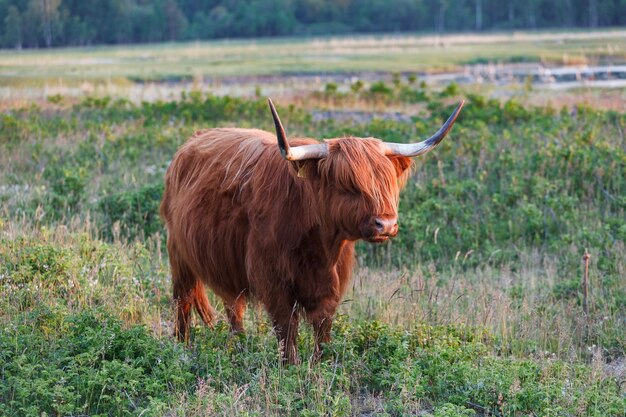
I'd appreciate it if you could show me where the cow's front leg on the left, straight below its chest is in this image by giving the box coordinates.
[267,302,300,364]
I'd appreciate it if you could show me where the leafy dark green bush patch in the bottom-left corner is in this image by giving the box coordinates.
[0,308,194,416]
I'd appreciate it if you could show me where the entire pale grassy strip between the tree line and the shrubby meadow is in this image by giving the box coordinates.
[0,29,626,111]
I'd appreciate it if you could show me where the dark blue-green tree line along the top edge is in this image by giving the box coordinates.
[0,0,626,49]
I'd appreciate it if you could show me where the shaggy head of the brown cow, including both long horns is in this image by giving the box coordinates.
[268,99,464,242]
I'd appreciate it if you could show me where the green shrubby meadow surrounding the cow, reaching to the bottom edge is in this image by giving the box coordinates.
[0,34,626,417]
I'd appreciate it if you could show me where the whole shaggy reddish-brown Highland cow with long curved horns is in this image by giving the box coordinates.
[161,100,463,363]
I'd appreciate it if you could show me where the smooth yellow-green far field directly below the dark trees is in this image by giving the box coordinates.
[0,29,626,86]
